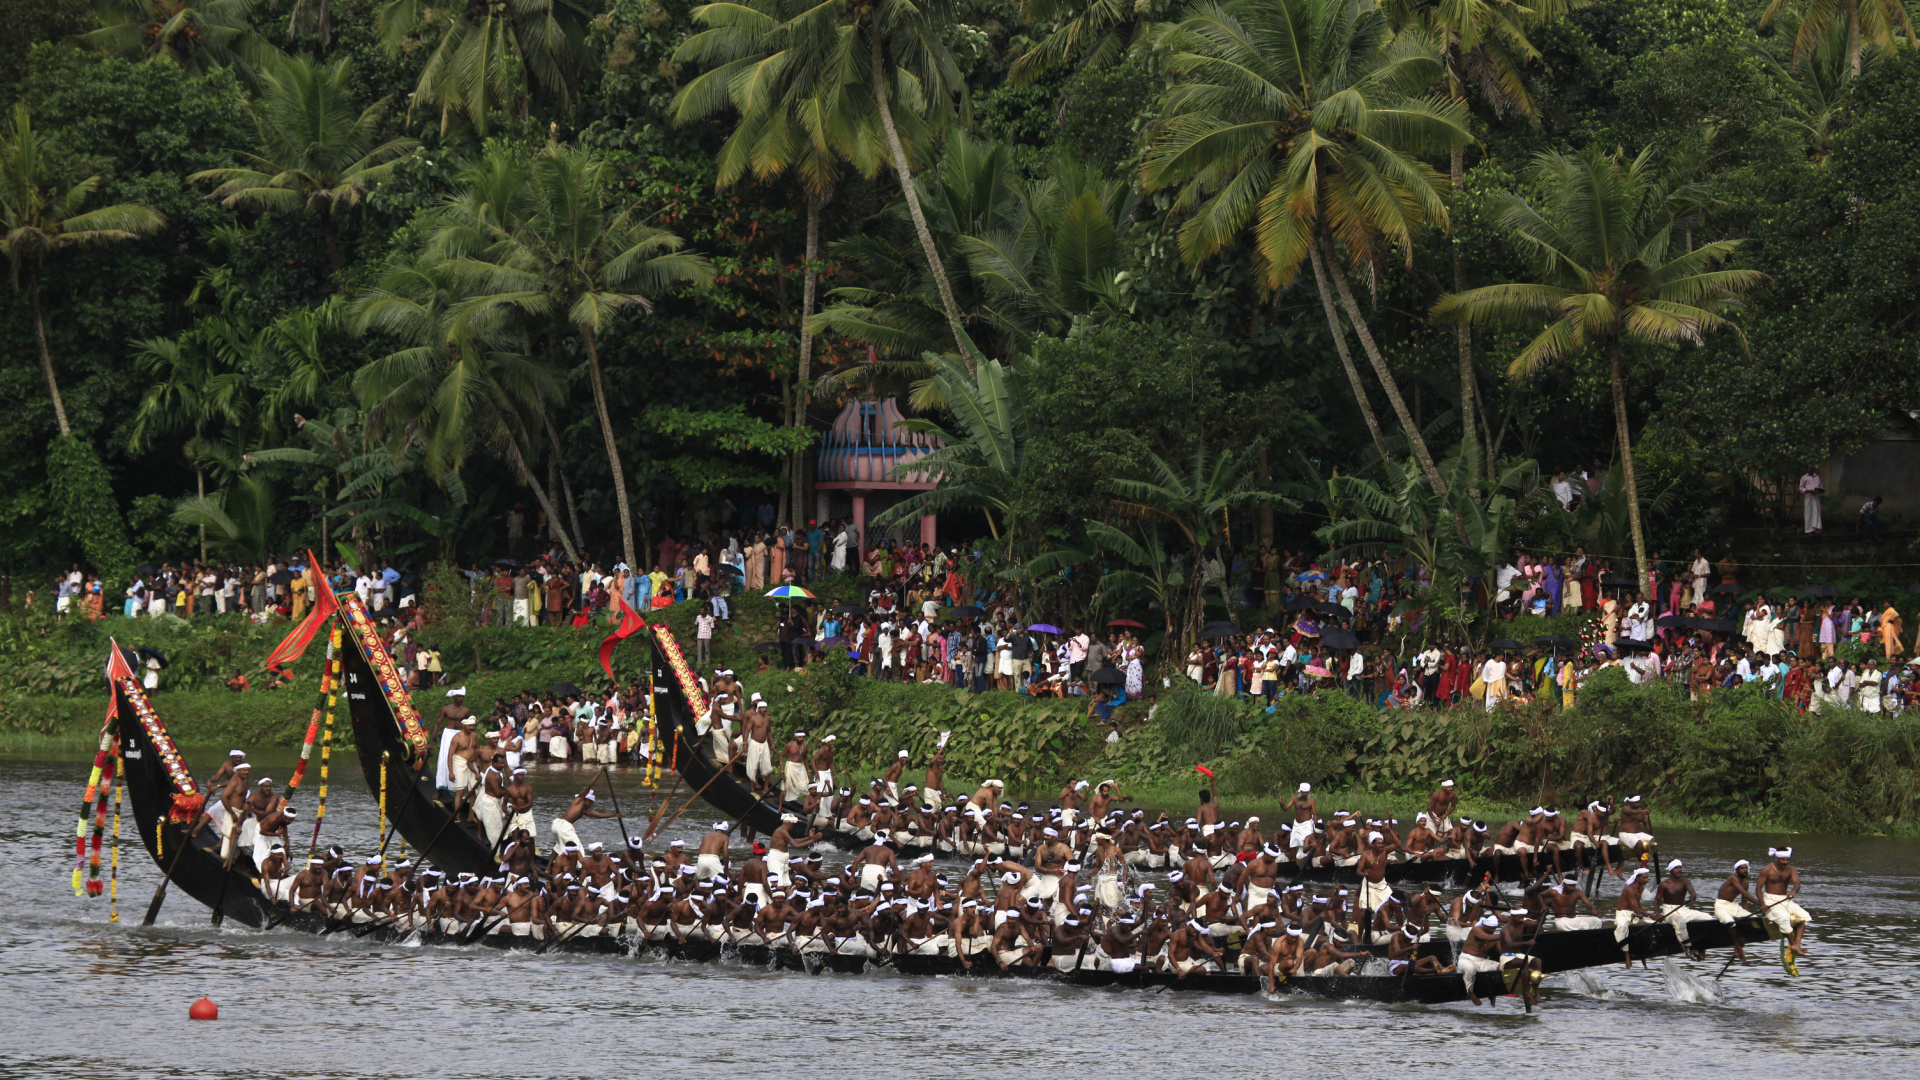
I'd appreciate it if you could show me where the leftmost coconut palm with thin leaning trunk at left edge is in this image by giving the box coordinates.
[0,104,167,436]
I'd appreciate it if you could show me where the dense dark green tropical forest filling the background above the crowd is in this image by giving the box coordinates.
[0,0,1920,584]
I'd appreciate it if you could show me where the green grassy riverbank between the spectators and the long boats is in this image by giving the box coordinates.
[0,582,1920,836]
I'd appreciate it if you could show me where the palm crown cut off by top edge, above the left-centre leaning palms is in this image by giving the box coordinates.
[374,0,588,135]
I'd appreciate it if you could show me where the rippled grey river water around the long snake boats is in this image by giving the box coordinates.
[0,749,1920,1080]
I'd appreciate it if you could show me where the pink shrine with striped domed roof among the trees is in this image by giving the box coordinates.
[814,398,943,555]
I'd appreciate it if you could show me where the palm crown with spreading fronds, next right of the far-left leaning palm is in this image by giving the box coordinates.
[186,56,419,273]
